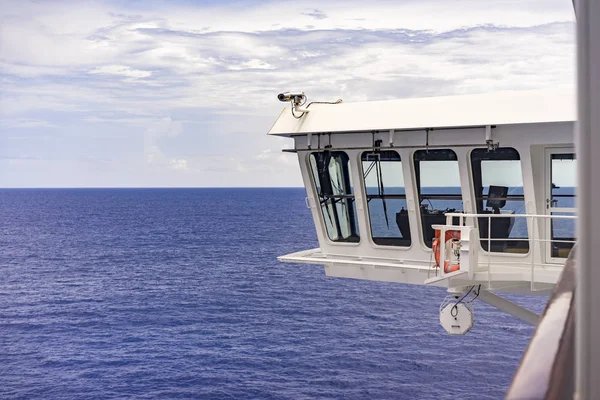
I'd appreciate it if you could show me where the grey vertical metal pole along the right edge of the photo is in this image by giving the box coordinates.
[576,0,600,400]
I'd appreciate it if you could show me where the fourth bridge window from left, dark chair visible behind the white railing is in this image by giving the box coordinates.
[471,147,529,253]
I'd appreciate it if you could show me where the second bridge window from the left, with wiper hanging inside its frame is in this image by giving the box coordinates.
[361,151,410,246]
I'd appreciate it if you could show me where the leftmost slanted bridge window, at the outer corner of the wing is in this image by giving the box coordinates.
[309,151,360,242]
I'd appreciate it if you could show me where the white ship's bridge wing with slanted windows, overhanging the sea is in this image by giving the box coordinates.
[269,88,577,334]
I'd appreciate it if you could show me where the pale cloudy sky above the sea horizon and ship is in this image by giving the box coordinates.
[0,0,576,187]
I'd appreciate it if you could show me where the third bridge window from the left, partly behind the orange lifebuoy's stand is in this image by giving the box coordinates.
[414,149,463,247]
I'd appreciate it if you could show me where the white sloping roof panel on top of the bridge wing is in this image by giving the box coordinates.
[269,89,577,136]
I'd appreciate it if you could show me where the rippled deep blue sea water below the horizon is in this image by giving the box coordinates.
[0,189,545,399]
